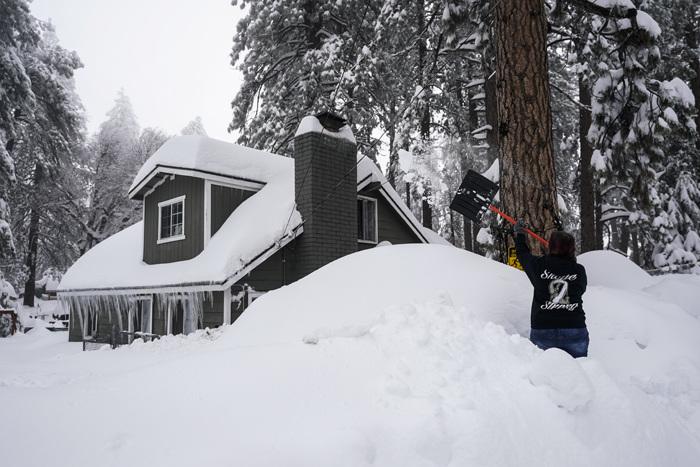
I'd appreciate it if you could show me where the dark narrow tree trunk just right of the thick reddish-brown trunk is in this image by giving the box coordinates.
[578,76,596,252]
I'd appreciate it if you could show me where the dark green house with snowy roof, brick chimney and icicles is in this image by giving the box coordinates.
[58,113,440,340]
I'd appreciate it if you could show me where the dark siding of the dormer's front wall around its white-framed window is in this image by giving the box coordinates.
[143,175,204,264]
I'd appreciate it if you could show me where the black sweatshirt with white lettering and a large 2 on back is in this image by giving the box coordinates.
[515,234,587,329]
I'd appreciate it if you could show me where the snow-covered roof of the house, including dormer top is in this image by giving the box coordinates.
[63,136,444,295]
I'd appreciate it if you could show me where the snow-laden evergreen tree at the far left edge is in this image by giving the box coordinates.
[0,1,83,306]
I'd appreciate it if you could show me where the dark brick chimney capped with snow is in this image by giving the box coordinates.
[294,112,357,278]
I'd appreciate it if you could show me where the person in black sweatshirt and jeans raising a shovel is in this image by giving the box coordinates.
[513,221,589,358]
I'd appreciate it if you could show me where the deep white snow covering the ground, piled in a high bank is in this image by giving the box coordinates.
[0,246,700,467]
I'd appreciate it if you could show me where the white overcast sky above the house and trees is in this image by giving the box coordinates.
[31,0,242,141]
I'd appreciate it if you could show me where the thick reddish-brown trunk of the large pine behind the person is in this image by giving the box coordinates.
[495,0,558,256]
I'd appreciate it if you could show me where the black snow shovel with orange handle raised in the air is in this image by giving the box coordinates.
[450,170,549,247]
